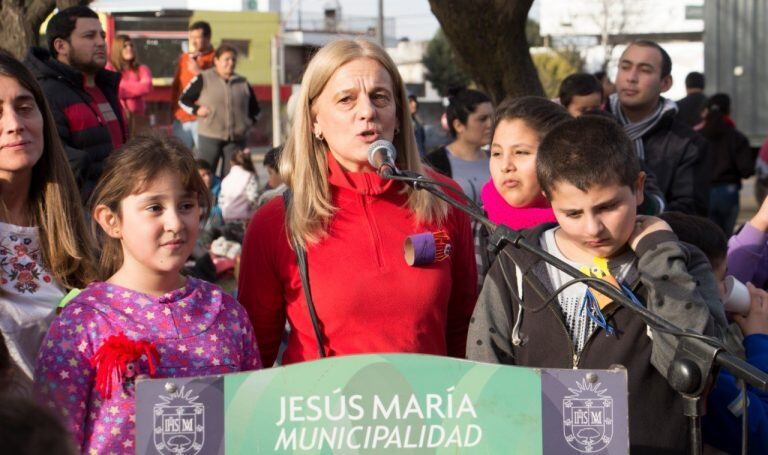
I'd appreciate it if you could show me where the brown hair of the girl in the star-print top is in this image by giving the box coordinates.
[90,133,211,280]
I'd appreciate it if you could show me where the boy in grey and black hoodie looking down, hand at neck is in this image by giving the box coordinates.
[467,116,719,454]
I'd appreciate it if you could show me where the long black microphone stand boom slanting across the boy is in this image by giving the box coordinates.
[388,169,768,455]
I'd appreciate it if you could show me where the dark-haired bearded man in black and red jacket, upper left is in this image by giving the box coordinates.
[24,6,127,203]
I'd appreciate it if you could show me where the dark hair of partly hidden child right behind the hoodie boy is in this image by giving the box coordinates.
[659,212,728,266]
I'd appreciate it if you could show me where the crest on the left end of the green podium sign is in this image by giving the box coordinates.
[153,387,205,455]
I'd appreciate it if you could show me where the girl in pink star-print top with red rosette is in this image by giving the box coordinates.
[35,136,261,454]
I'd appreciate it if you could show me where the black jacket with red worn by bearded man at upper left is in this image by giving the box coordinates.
[24,47,127,203]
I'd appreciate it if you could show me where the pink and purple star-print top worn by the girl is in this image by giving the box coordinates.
[35,278,261,454]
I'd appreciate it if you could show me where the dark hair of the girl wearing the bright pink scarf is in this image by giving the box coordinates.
[493,96,571,141]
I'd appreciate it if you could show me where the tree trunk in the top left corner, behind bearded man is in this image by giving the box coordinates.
[0,0,90,59]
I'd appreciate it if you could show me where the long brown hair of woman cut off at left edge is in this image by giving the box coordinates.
[0,50,96,289]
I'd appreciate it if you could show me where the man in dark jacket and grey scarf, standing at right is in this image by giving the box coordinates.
[608,40,710,216]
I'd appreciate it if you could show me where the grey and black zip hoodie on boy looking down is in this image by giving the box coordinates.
[467,224,719,455]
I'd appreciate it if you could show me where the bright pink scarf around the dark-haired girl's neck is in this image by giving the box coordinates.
[480,180,557,230]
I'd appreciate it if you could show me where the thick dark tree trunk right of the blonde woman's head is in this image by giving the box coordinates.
[429,0,544,104]
